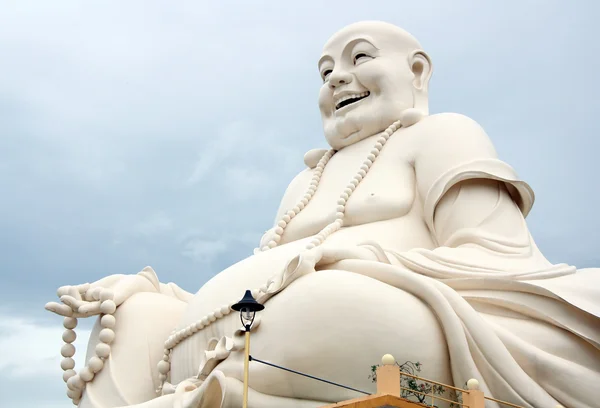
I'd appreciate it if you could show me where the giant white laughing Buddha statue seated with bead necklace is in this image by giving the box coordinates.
[46,22,600,408]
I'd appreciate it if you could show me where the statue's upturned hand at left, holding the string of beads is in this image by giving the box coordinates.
[46,268,158,317]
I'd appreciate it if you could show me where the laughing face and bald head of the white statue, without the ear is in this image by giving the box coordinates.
[319,22,420,150]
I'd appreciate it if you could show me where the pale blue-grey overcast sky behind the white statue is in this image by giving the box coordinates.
[0,0,600,408]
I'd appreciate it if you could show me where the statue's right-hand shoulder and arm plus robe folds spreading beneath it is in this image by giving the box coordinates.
[394,114,572,279]
